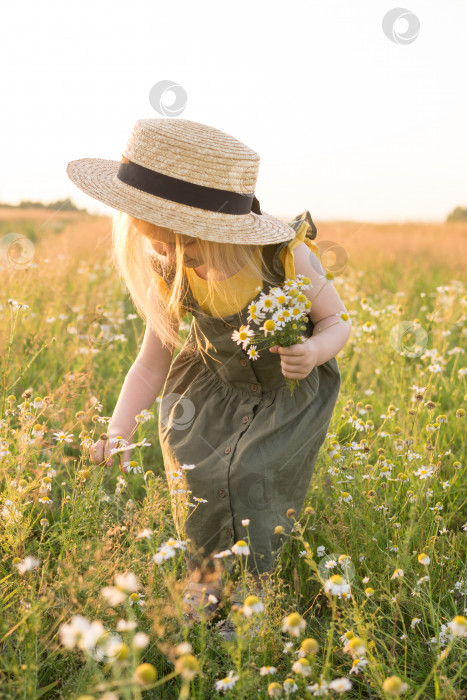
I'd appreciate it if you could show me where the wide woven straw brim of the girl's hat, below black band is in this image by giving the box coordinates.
[66,158,295,245]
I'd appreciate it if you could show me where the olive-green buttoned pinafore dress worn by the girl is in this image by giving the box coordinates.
[158,213,341,574]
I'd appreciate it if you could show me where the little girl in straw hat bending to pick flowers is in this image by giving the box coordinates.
[67,118,350,636]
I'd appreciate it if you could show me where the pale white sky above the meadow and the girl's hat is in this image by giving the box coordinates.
[0,0,467,222]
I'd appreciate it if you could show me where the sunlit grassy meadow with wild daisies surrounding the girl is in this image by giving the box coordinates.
[0,209,467,700]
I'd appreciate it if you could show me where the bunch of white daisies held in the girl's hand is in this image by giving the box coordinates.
[232,275,313,394]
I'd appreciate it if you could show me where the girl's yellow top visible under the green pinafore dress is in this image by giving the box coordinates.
[155,221,318,318]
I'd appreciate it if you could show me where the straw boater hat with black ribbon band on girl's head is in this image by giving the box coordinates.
[67,117,295,245]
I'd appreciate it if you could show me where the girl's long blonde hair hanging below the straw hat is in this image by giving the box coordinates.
[112,210,277,348]
